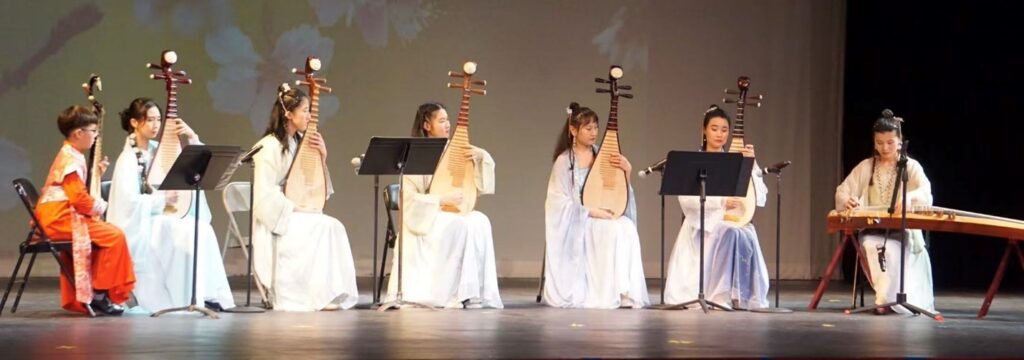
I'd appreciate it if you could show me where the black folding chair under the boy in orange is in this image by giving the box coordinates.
[0,178,96,317]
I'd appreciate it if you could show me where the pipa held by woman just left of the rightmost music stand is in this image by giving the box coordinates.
[585,65,633,218]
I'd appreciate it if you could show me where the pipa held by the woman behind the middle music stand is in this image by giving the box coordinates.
[428,61,487,215]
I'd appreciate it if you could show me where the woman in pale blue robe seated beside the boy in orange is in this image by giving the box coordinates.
[106,97,234,312]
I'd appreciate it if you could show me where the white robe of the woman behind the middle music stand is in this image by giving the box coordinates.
[385,147,505,309]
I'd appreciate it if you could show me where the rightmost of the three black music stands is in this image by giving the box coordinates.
[655,151,754,314]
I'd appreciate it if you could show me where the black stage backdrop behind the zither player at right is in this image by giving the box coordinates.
[842,1,1024,289]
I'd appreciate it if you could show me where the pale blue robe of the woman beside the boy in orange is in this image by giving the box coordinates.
[106,141,234,312]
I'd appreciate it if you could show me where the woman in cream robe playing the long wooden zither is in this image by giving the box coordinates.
[836,114,935,315]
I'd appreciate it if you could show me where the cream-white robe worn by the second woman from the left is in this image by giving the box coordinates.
[253,135,359,311]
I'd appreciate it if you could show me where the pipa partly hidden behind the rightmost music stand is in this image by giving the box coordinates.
[723,77,762,227]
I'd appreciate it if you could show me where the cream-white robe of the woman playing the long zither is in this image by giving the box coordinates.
[836,159,935,314]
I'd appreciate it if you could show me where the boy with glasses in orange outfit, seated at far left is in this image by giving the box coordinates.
[36,105,135,315]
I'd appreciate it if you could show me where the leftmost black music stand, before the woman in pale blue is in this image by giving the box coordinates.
[152,145,242,319]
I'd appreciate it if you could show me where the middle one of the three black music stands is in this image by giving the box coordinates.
[359,136,447,311]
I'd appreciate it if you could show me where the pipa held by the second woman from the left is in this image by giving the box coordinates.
[285,56,331,213]
